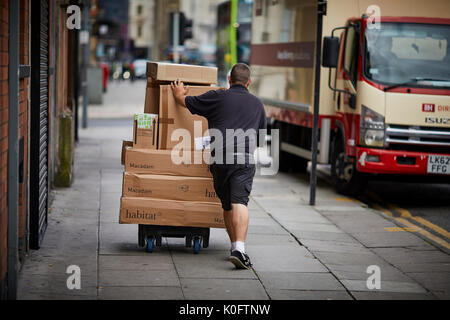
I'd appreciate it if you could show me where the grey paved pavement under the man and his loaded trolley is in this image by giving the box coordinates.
[19,83,450,300]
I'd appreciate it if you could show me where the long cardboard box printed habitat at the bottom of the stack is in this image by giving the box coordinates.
[119,197,225,228]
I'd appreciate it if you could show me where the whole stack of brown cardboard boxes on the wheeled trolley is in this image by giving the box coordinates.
[119,62,225,228]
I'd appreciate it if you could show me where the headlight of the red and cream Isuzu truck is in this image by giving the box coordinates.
[360,105,385,147]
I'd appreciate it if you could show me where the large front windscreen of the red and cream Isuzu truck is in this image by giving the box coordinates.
[364,22,450,88]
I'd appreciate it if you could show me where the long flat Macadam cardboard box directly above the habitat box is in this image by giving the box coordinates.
[122,172,220,203]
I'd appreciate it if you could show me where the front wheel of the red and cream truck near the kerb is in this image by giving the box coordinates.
[331,134,367,196]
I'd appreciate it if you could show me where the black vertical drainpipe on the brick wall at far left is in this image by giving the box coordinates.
[7,0,20,300]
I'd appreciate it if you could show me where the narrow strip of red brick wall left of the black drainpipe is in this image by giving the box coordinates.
[0,0,9,295]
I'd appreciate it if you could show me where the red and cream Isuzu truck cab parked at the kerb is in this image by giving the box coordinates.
[324,15,450,194]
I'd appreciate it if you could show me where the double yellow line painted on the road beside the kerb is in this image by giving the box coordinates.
[369,192,450,250]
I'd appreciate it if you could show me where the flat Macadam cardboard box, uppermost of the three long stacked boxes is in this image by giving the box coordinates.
[125,147,212,178]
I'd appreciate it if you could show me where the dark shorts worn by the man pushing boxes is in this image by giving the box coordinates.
[210,164,256,211]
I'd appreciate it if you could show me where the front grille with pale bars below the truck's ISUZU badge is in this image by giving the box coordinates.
[386,125,450,147]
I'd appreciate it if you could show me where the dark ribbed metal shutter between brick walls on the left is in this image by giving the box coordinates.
[30,0,49,249]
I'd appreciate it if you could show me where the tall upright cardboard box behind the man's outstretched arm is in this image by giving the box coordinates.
[157,86,219,150]
